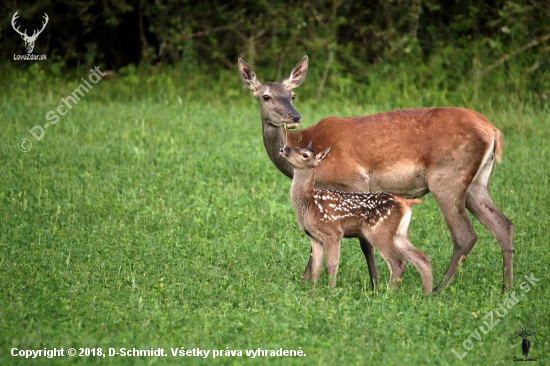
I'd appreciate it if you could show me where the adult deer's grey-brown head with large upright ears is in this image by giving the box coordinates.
[239,56,309,129]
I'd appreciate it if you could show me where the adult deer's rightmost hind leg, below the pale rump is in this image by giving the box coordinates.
[466,156,514,291]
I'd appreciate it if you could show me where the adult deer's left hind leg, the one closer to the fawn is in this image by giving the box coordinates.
[430,172,477,292]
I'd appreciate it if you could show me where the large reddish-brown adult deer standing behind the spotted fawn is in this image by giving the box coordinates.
[238,56,514,291]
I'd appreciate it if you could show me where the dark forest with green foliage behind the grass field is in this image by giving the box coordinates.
[0,0,550,95]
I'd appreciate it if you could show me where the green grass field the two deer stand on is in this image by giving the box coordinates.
[0,67,550,365]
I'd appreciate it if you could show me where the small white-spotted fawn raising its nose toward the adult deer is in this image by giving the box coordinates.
[280,143,433,293]
